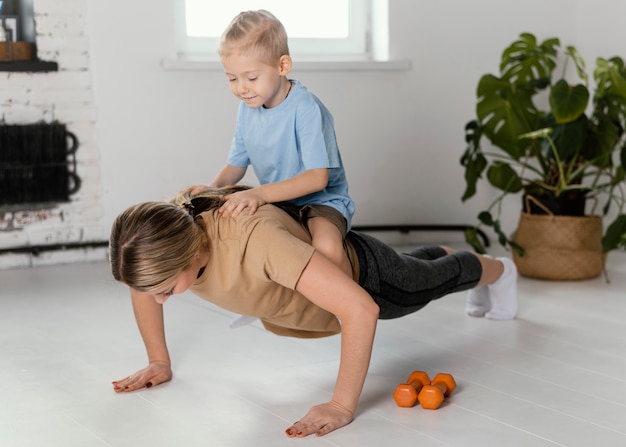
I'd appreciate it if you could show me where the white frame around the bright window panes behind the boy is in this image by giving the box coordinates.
[174,0,375,61]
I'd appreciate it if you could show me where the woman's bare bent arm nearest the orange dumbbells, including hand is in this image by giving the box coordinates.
[286,253,379,437]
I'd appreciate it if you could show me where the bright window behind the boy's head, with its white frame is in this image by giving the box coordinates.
[176,0,376,60]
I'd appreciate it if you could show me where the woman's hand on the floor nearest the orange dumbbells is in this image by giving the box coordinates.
[285,400,352,438]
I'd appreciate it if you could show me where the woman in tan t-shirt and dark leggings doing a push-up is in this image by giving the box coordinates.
[110,187,517,437]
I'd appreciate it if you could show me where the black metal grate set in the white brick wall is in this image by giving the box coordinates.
[0,123,80,205]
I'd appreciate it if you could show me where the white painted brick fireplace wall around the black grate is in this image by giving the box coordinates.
[0,0,106,268]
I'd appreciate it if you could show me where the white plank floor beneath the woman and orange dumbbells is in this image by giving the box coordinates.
[0,245,626,447]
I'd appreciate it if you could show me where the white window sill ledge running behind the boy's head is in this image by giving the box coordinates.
[161,59,413,72]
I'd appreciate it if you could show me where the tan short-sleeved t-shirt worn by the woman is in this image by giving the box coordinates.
[190,205,341,338]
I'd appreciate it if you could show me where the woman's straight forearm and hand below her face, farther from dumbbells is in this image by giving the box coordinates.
[113,289,172,392]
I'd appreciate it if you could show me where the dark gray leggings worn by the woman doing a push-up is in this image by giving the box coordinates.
[346,231,482,320]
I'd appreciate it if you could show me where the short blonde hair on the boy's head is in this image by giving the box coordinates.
[218,9,289,65]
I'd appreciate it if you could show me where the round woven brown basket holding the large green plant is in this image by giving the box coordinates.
[513,212,605,280]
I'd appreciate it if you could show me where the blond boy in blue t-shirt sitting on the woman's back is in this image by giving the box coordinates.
[204,10,354,275]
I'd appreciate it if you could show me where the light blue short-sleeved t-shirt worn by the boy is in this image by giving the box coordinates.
[228,80,354,228]
